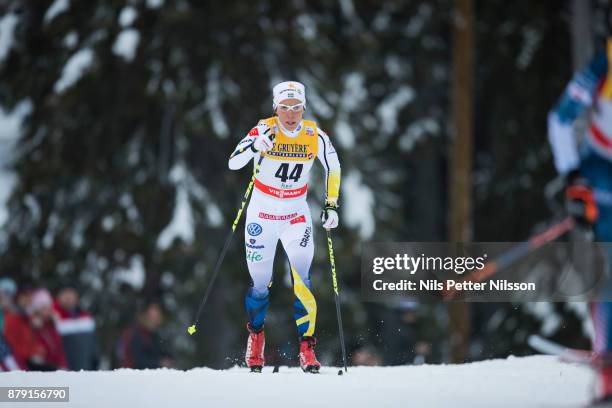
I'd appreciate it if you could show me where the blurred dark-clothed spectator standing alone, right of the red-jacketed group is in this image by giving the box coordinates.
[118,302,174,369]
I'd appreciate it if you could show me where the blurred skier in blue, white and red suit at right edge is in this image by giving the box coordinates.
[548,39,612,400]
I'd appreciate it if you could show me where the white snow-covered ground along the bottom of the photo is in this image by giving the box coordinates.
[0,356,593,408]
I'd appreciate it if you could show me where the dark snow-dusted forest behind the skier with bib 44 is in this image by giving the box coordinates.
[0,0,604,368]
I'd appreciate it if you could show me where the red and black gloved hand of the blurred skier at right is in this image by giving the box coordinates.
[565,171,599,225]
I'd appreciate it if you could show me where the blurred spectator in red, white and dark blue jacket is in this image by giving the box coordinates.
[53,286,99,371]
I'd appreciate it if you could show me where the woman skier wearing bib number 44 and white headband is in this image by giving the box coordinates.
[228,81,340,373]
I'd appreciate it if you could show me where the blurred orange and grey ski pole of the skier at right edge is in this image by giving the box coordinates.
[442,217,576,299]
